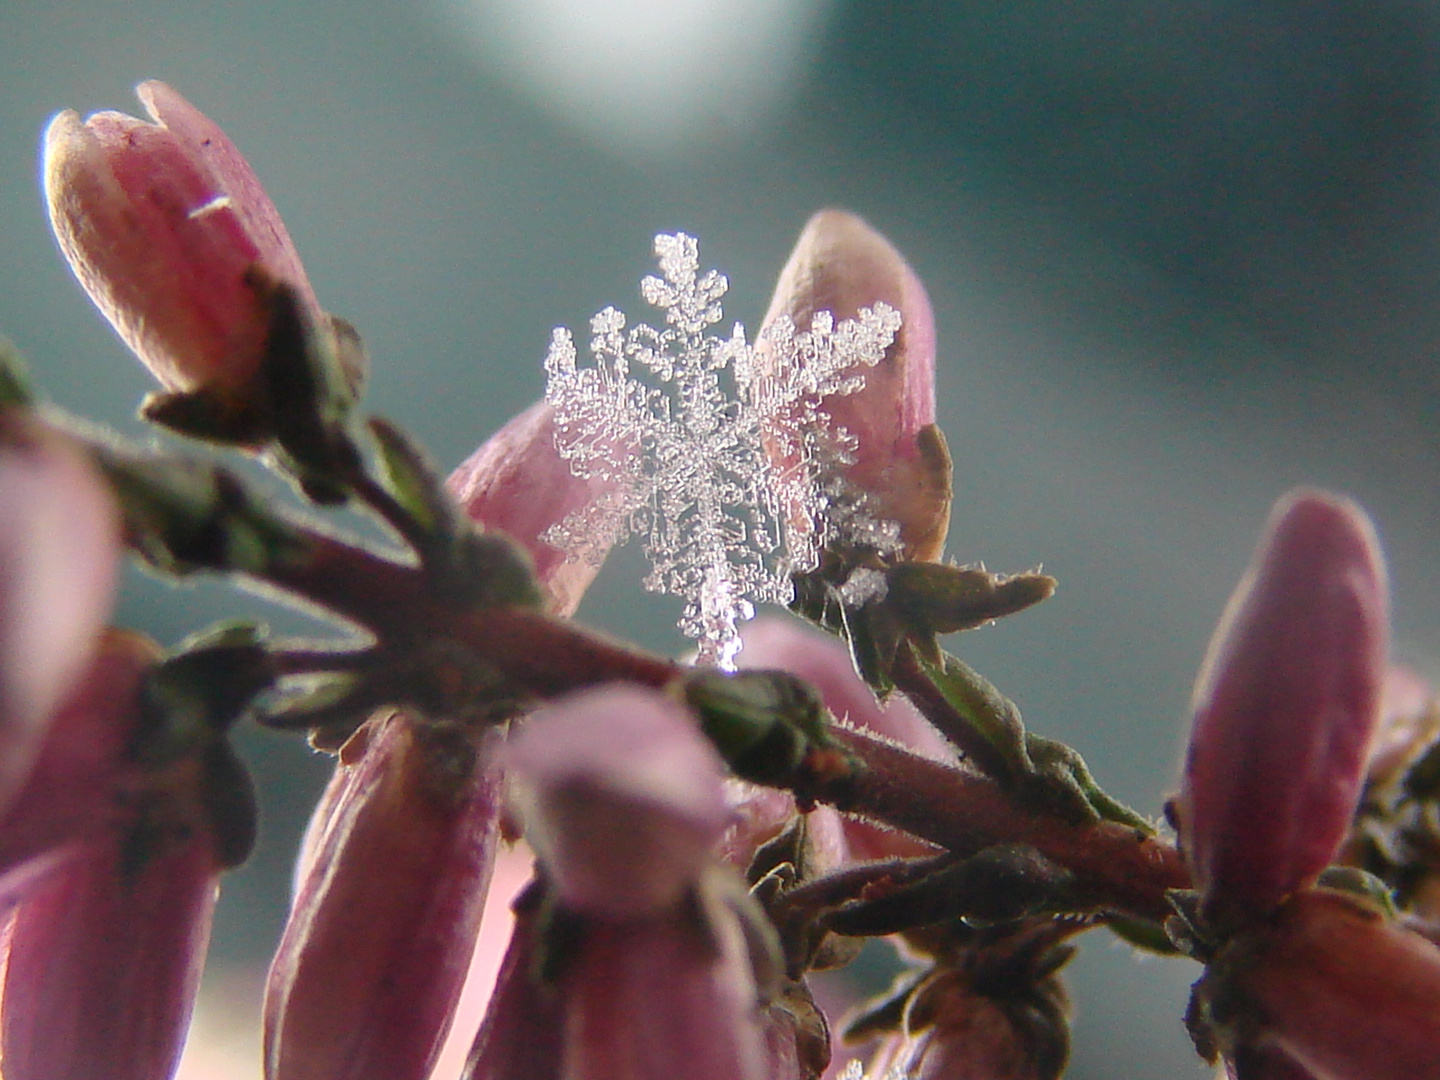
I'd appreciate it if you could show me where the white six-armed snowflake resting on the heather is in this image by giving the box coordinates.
[544,233,900,667]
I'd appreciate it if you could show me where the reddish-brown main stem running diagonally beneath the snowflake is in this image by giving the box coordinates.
[253,536,1189,922]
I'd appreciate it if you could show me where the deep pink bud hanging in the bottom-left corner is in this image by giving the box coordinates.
[0,825,220,1080]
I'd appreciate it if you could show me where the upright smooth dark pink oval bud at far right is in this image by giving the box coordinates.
[1178,491,1388,926]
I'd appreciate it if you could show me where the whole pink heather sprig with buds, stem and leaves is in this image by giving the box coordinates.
[0,82,1440,1080]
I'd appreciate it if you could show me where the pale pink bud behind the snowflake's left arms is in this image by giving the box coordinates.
[446,402,606,616]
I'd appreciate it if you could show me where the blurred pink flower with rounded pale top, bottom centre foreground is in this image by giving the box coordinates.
[465,685,765,1080]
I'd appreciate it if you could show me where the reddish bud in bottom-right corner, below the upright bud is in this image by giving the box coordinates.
[1202,890,1440,1080]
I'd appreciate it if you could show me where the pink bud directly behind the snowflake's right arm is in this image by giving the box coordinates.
[759,210,950,560]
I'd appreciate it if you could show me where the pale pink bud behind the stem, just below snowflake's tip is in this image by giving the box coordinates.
[740,616,955,860]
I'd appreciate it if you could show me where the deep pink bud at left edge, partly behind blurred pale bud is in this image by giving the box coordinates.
[0,631,160,907]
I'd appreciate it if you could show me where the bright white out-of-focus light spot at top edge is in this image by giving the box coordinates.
[435,0,829,151]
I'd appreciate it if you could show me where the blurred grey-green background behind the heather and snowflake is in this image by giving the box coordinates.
[0,0,1440,1080]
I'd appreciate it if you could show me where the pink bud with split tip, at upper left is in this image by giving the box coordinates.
[45,82,320,396]
